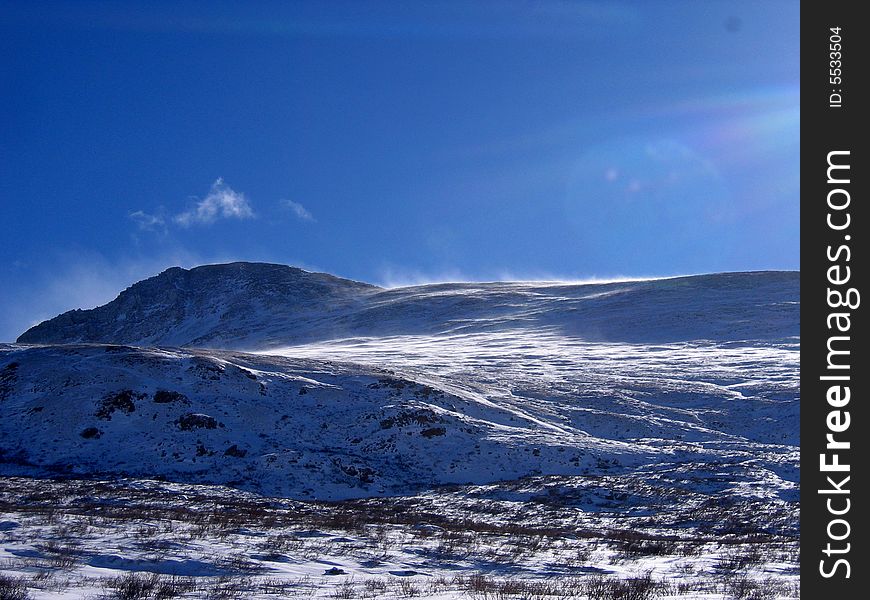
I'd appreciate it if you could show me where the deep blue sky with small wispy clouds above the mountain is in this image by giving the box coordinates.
[0,0,800,340]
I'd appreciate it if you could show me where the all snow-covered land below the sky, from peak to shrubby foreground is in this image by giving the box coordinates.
[0,265,800,600]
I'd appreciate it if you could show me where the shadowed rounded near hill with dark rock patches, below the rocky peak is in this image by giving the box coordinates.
[0,345,644,499]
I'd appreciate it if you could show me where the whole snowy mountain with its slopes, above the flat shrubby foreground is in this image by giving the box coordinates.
[0,263,800,499]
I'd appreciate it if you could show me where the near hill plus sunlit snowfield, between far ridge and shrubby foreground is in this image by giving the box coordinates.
[0,335,799,499]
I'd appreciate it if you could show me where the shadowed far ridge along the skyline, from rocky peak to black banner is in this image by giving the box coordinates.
[18,263,800,350]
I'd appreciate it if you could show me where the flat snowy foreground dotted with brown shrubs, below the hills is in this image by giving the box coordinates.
[0,474,799,600]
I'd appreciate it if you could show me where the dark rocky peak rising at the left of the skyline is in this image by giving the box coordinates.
[18,262,379,347]
